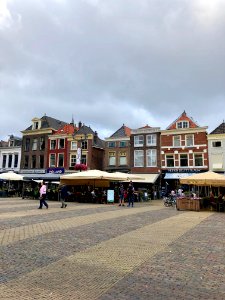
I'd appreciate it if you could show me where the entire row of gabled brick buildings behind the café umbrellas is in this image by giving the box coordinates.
[0,111,225,191]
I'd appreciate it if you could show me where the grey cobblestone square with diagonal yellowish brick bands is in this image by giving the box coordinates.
[0,198,225,300]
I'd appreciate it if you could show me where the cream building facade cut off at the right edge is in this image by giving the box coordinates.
[208,122,225,173]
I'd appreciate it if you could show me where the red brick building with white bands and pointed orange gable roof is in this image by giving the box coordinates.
[161,111,208,188]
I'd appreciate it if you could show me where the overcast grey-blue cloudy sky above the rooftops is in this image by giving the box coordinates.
[0,0,225,139]
